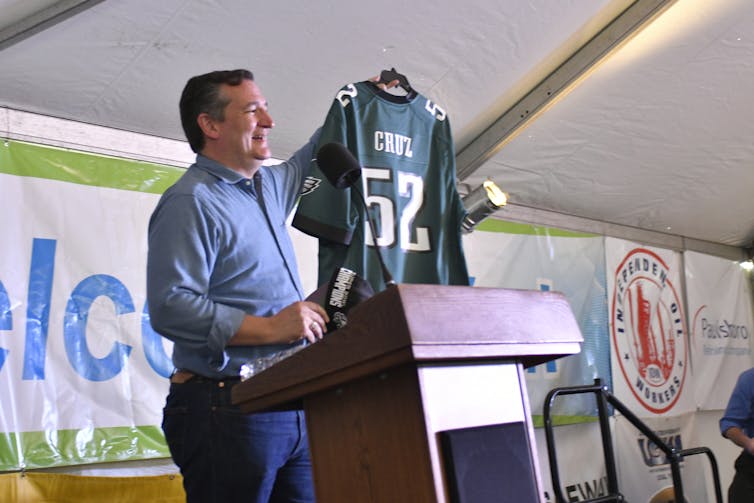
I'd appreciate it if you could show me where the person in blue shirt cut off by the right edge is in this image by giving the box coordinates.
[720,368,754,503]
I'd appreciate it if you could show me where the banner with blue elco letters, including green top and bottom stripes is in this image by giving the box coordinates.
[0,142,182,470]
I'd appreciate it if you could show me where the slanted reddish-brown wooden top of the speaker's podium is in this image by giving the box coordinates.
[232,284,583,412]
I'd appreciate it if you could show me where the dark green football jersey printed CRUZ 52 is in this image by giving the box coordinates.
[293,82,469,291]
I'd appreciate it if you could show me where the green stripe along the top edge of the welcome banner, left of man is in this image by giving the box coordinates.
[0,141,185,194]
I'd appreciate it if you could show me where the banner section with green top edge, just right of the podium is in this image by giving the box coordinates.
[464,220,610,416]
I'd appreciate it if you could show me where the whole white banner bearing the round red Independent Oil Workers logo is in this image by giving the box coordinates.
[605,238,694,417]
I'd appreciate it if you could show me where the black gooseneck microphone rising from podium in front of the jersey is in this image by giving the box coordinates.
[317,142,395,286]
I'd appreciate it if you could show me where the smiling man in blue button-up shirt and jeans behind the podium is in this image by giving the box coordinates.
[147,70,329,503]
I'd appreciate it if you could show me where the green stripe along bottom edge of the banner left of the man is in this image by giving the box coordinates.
[0,426,170,471]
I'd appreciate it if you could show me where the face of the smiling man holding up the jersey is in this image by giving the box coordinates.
[217,80,275,167]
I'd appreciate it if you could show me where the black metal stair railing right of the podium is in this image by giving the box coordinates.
[544,379,723,503]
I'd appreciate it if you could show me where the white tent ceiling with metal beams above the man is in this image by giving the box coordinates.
[0,0,754,252]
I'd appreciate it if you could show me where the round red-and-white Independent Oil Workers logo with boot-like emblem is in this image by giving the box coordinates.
[611,248,688,414]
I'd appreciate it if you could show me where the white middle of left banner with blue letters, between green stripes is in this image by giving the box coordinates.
[0,174,170,432]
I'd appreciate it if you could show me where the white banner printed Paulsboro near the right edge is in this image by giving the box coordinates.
[684,252,754,410]
